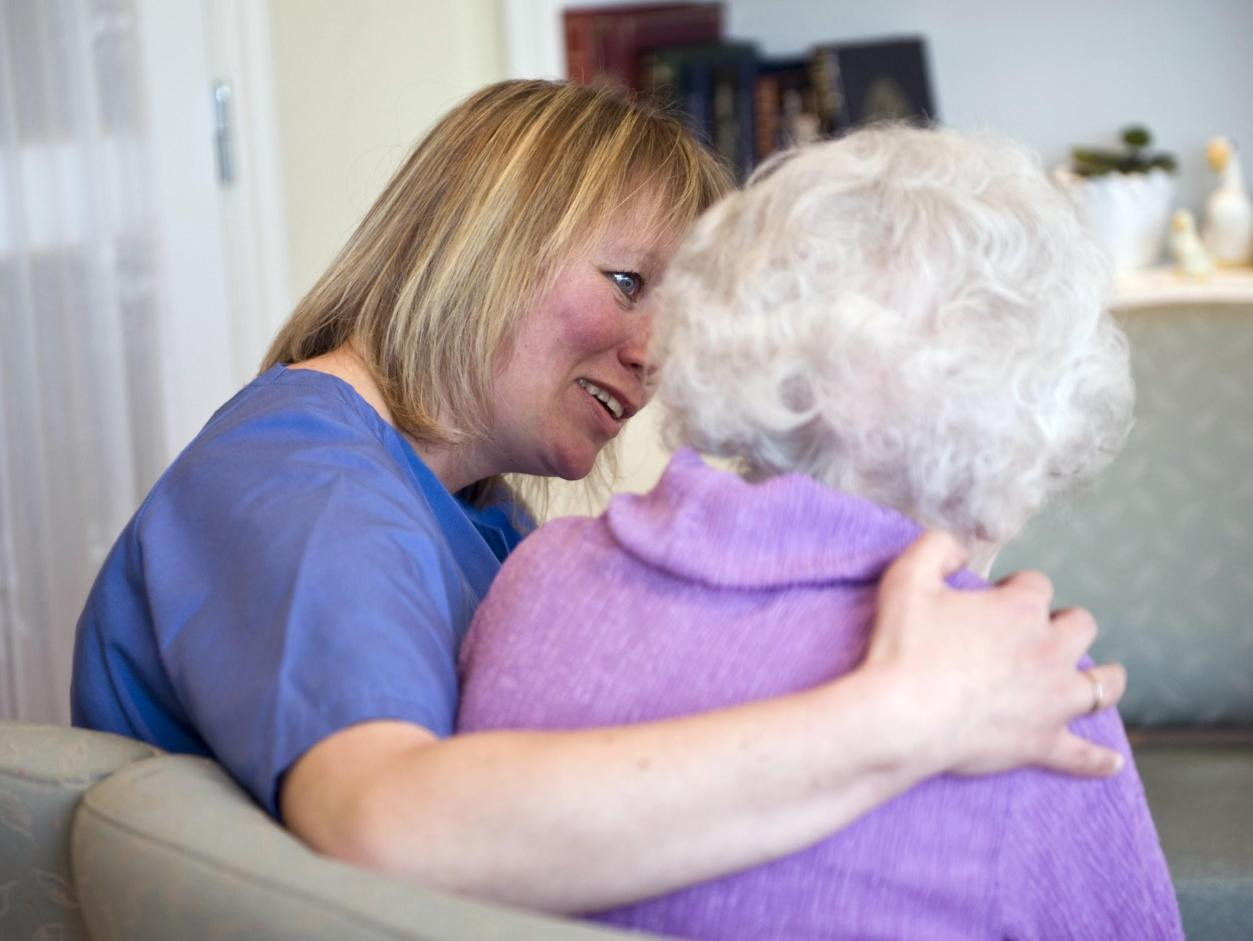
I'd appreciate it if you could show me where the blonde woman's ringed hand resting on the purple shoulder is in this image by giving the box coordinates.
[866,533,1126,777]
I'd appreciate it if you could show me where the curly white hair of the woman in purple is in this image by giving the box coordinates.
[653,125,1134,545]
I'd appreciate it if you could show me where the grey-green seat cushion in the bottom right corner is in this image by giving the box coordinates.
[1135,743,1253,941]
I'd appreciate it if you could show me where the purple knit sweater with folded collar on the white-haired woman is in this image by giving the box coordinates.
[459,452,1183,941]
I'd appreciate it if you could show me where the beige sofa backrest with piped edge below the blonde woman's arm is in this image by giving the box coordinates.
[74,756,666,941]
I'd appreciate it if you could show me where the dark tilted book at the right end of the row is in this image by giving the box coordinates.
[809,38,938,137]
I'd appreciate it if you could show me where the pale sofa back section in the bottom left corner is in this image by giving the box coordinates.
[0,722,158,941]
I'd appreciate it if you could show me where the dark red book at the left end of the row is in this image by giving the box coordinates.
[563,3,722,91]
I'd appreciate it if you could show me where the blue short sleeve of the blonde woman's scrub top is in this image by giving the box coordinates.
[137,398,479,817]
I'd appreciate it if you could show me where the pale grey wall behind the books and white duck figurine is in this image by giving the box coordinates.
[727,0,1253,209]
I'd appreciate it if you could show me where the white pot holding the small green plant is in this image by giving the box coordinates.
[1054,167,1175,271]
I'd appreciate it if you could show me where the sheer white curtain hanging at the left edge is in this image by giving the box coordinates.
[0,0,164,722]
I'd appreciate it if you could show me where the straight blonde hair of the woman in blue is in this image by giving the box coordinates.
[262,80,728,508]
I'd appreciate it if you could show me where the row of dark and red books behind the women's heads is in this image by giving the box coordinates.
[564,3,937,179]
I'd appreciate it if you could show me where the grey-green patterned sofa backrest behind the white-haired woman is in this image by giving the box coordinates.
[996,306,1253,725]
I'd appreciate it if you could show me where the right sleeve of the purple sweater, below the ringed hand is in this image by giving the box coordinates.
[1000,710,1183,941]
